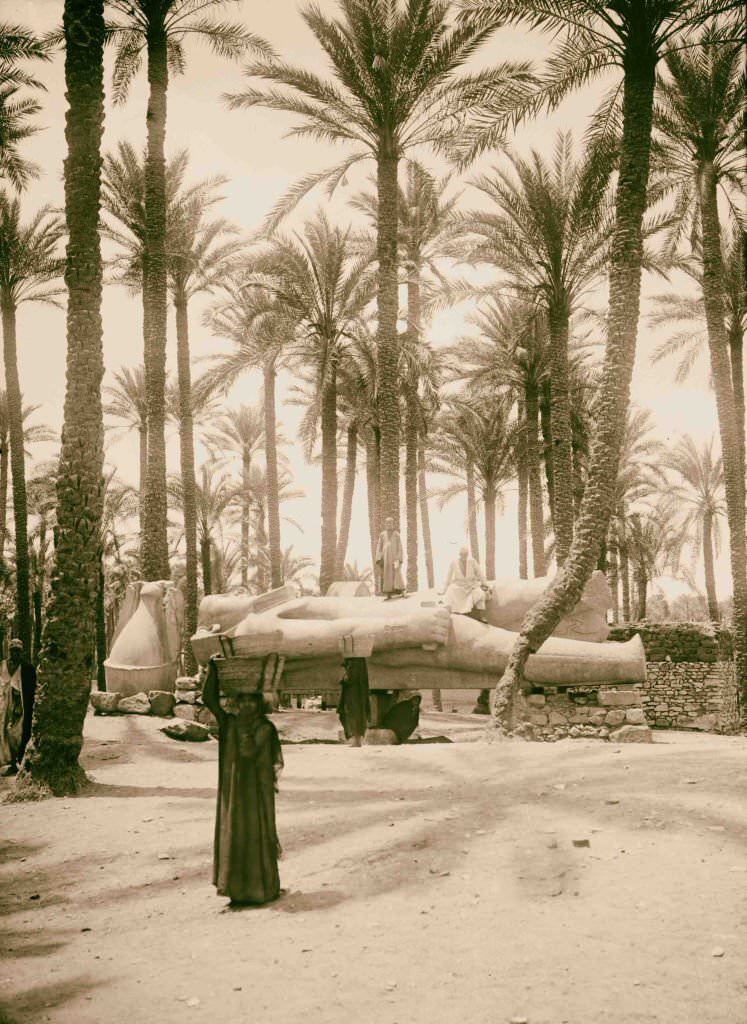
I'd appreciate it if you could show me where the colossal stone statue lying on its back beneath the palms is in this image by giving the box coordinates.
[192,573,646,692]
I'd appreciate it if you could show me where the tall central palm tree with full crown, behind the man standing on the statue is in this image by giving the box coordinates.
[229,0,527,526]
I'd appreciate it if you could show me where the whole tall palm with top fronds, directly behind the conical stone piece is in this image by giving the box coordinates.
[108,0,269,580]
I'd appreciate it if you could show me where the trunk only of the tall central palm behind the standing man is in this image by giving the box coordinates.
[376,148,400,530]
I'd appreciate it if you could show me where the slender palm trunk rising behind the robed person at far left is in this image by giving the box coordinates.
[0,289,31,657]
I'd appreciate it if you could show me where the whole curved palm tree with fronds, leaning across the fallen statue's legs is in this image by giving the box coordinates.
[462,0,733,727]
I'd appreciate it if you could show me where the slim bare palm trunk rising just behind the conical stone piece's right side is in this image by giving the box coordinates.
[174,288,198,673]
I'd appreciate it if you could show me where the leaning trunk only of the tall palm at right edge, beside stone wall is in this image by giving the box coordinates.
[698,163,747,696]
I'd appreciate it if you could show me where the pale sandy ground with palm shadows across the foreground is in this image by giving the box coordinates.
[0,712,747,1024]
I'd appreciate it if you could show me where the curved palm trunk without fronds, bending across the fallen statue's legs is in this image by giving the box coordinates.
[493,41,657,729]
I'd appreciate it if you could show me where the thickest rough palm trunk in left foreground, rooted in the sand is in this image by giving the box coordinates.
[16,0,105,796]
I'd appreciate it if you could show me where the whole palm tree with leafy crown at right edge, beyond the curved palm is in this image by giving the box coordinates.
[654,36,747,698]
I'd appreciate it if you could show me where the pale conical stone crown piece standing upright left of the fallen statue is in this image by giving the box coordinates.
[103,580,183,696]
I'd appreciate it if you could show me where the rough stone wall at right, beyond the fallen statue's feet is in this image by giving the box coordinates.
[610,623,739,732]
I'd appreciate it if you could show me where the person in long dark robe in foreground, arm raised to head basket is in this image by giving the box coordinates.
[202,663,283,905]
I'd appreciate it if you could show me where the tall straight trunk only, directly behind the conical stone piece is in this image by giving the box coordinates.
[140,18,170,580]
